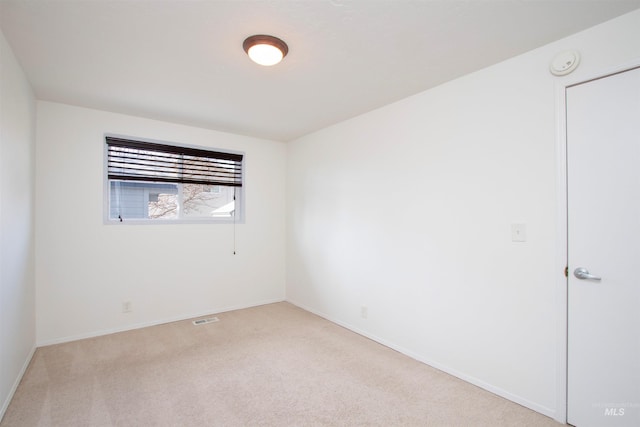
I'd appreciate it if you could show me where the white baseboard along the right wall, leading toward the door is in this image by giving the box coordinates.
[286,299,556,419]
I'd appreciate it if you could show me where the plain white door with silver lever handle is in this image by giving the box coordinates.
[566,68,640,427]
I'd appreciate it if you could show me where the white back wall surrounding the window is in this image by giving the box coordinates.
[36,101,286,345]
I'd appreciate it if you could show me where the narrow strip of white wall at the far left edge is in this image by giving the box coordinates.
[0,28,36,419]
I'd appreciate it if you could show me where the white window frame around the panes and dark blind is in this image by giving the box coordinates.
[102,133,247,225]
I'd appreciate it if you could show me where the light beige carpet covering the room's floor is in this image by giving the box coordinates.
[0,303,560,427]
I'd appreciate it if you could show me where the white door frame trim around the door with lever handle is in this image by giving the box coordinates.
[554,58,640,424]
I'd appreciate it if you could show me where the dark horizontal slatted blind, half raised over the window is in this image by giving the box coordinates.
[106,137,242,187]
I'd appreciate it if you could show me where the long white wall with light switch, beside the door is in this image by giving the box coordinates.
[287,11,640,419]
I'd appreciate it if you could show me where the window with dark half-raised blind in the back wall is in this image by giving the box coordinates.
[106,137,243,222]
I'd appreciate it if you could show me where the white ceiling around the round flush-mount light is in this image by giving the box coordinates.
[0,0,640,141]
